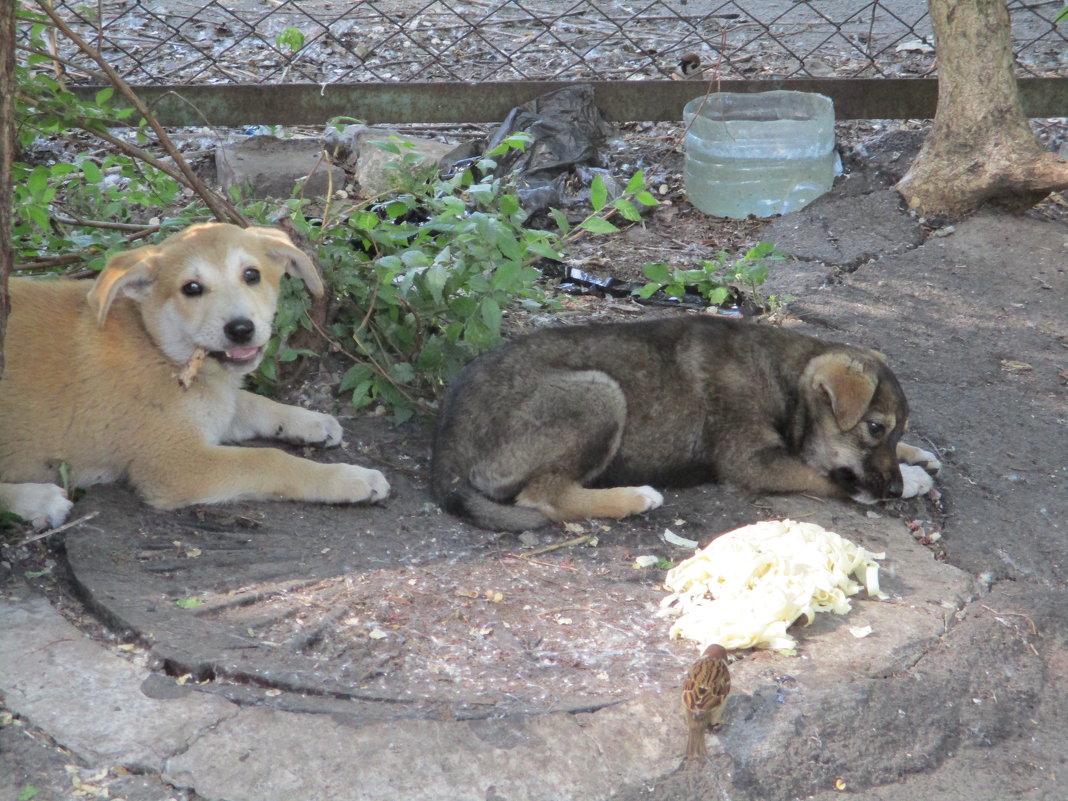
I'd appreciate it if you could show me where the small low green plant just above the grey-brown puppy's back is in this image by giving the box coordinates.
[634,242,785,308]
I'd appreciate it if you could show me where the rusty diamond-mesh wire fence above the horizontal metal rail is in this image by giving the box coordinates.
[29,0,1068,84]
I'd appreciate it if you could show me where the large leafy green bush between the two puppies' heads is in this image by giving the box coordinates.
[254,134,656,421]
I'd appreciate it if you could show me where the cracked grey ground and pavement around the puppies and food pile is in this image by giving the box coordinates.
[6,126,1068,801]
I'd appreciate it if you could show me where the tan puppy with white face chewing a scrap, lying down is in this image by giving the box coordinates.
[0,223,389,527]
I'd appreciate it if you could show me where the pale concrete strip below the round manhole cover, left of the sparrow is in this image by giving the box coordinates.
[164,697,678,801]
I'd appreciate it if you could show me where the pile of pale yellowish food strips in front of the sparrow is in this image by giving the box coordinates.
[660,520,888,651]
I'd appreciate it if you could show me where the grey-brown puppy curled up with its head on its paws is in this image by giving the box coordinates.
[433,315,940,531]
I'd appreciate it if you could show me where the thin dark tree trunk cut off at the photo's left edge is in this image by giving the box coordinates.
[0,0,15,375]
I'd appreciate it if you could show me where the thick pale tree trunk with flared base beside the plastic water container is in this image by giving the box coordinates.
[897,0,1068,217]
